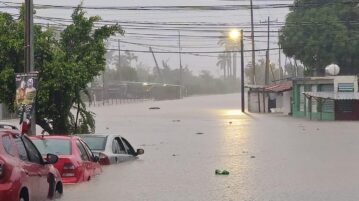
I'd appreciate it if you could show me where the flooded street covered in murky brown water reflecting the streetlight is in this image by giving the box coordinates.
[61,94,359,201]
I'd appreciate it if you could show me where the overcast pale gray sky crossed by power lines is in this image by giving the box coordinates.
[0,0,292,75]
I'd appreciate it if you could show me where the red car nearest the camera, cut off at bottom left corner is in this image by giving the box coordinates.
[0,129,63,201]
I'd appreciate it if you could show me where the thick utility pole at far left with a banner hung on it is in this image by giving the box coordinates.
[24,0,36,135]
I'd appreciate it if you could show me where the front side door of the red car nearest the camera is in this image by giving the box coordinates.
[13,135,49,201]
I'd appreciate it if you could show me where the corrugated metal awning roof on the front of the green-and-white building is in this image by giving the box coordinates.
[303,92,359,100]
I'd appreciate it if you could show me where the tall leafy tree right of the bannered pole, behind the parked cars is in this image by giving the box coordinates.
[37,5,123,134]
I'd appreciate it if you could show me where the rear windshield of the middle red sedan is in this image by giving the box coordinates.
[32,139,71,155]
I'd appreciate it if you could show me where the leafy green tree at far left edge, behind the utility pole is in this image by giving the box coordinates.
[0,7,53,111]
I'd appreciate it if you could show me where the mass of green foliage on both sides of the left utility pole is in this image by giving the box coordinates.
[0,5,123,134]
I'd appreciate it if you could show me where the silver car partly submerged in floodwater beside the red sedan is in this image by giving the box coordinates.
[78,134,144,165]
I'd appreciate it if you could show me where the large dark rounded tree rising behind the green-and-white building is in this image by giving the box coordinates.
[280,0,359,75]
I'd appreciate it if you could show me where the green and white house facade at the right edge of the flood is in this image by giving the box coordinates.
[292,76,359,120]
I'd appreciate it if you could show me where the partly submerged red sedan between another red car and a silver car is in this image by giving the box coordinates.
[31,136,101,183]
